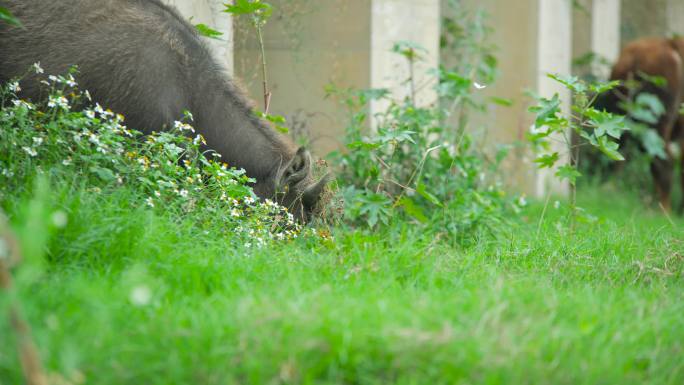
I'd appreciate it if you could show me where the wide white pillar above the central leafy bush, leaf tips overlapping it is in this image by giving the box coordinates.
[370,0,441,118]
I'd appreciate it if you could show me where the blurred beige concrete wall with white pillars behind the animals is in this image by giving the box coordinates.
[162,0,684,195]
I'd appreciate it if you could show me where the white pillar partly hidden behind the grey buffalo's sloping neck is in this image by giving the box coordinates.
[164,0,233,74]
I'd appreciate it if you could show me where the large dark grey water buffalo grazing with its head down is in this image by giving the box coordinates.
[0,0,326,221]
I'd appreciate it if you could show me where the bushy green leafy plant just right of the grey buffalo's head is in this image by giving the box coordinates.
[327,42,517,240]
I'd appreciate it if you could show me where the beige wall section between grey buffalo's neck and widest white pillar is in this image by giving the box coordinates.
[235,0,372,155]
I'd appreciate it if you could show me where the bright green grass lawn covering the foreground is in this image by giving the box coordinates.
[0,184,684,385]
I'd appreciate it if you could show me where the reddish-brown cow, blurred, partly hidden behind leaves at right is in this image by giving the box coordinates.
[598,38,684,211]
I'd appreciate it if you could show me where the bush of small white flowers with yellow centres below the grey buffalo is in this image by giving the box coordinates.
[0,64,310,247]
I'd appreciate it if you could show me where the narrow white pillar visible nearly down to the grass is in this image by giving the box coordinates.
[535,0,572,196]
